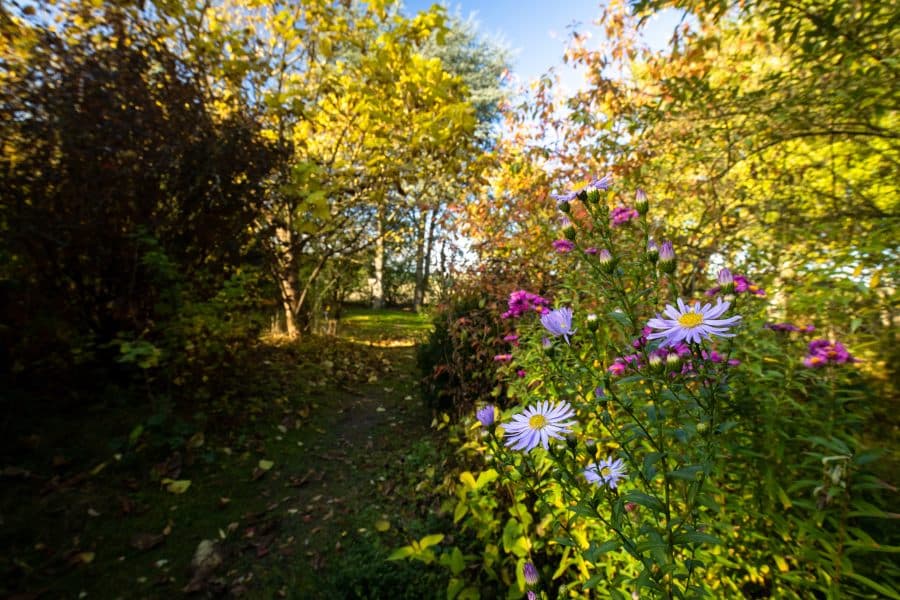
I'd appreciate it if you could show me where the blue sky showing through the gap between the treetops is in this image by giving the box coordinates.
[404,0,678,87]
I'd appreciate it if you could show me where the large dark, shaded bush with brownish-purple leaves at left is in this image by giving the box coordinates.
[0,10,276,396]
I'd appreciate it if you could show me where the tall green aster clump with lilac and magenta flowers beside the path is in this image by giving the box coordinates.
[402,176,900,599]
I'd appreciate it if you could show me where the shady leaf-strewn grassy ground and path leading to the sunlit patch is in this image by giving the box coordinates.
[0,311,446,600]
